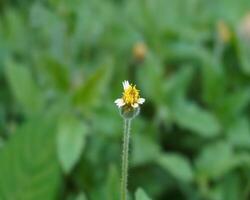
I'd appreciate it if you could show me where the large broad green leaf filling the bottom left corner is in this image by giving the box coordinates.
[0,117,61,200]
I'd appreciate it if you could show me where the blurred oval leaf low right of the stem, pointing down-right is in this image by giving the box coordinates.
[158,153,193,182]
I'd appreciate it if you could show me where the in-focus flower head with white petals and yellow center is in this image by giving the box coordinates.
[115,81,145,108]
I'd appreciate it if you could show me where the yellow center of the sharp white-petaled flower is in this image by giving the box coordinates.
[122,85,140,106]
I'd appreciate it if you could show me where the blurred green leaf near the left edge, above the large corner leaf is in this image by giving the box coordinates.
[5,61,42,112]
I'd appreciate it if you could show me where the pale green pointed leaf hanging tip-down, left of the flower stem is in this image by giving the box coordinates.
[57,116,86,174]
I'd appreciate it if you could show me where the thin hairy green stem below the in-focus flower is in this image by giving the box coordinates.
[121,119,131,200]
